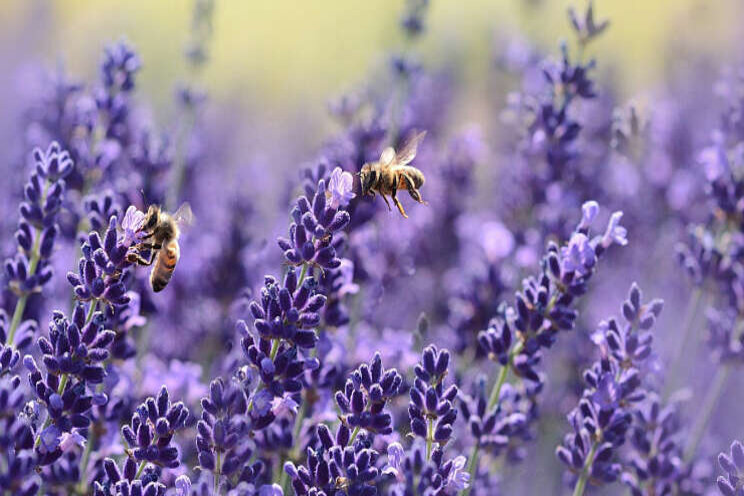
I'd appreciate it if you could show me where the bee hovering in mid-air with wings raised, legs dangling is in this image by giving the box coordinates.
[359,131,427,219]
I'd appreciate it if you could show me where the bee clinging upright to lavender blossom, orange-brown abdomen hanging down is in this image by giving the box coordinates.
[128,203,194,293]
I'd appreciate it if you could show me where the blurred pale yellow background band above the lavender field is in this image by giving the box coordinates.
[0,0,744,120]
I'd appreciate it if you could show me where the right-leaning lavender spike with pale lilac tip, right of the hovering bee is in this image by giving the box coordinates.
[466,203,619,492]
